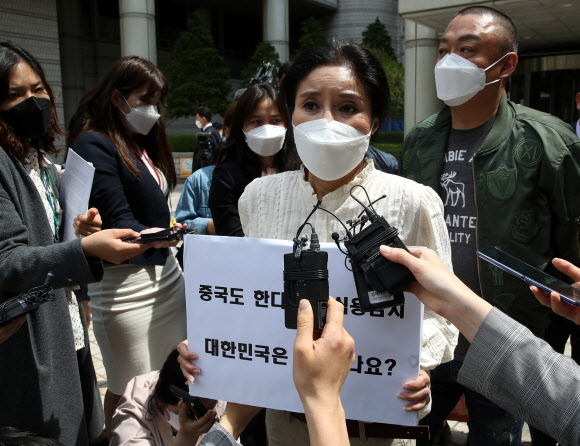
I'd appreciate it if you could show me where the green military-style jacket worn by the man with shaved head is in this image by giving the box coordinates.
[400,94,580,336]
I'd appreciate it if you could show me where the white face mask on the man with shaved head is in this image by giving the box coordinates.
[435,53,509,107]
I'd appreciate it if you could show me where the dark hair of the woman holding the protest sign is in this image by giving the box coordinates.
[280,39,389,128]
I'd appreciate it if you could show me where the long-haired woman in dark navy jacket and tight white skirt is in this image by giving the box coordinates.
[70,56,186,436]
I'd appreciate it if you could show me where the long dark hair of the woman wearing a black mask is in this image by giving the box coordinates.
[0,40,64,160]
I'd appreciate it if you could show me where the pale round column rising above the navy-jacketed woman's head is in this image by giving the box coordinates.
[119,0,157,64]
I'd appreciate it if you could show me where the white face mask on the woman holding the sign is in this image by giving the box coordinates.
[294,119,372,181]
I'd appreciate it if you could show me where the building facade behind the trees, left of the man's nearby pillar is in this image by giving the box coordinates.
[0,0,404,145]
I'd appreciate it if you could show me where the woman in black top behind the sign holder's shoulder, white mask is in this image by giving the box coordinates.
[208,85,300,237]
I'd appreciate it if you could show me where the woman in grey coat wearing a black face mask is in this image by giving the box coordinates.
[0,42,151,445]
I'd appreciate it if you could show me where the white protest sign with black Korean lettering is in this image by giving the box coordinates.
[184,235,423,426]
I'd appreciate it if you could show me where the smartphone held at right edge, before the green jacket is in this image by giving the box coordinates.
[477,246,580,307]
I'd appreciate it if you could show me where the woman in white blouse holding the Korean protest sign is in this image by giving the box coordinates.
[239,41,457,446]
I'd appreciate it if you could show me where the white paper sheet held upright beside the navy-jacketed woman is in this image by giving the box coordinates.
[59,149,95,242]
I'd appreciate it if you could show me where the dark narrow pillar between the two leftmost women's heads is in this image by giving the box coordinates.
[56,0,85,128]
